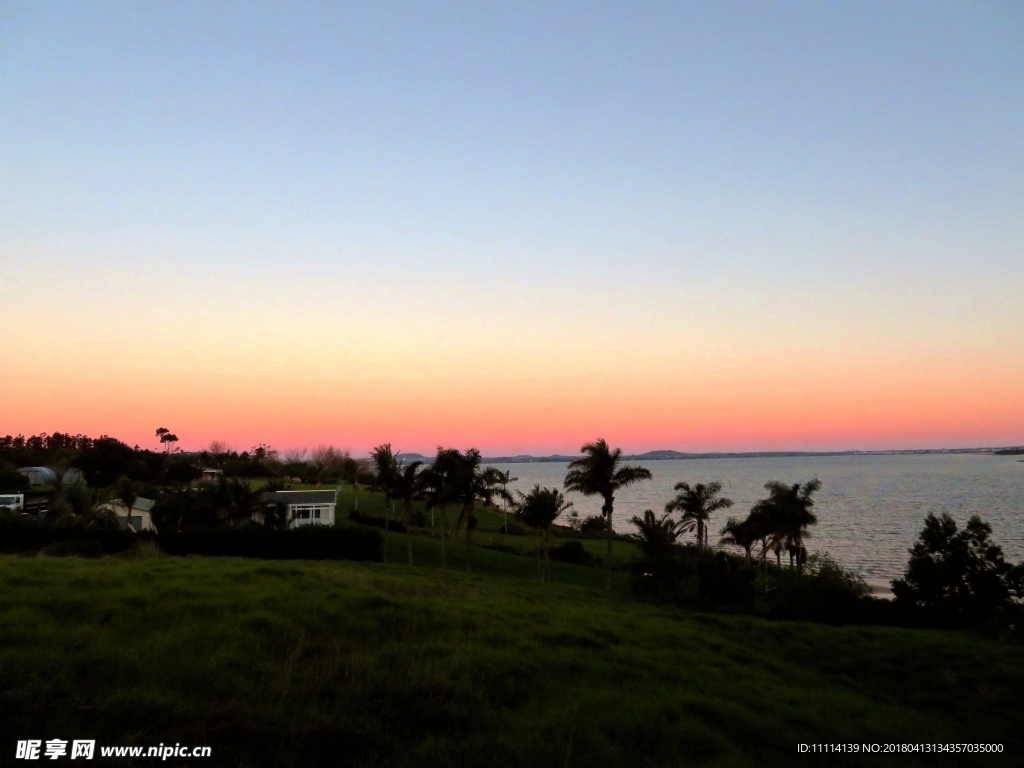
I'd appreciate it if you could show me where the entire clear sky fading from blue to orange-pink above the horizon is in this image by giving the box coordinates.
[0,0,1024,455]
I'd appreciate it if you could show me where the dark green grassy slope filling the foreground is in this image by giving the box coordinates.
[0,538,1024,766]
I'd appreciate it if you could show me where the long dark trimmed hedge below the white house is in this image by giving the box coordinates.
[157,524,382,561]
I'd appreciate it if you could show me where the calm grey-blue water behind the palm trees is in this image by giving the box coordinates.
[496,454,1024,587]
